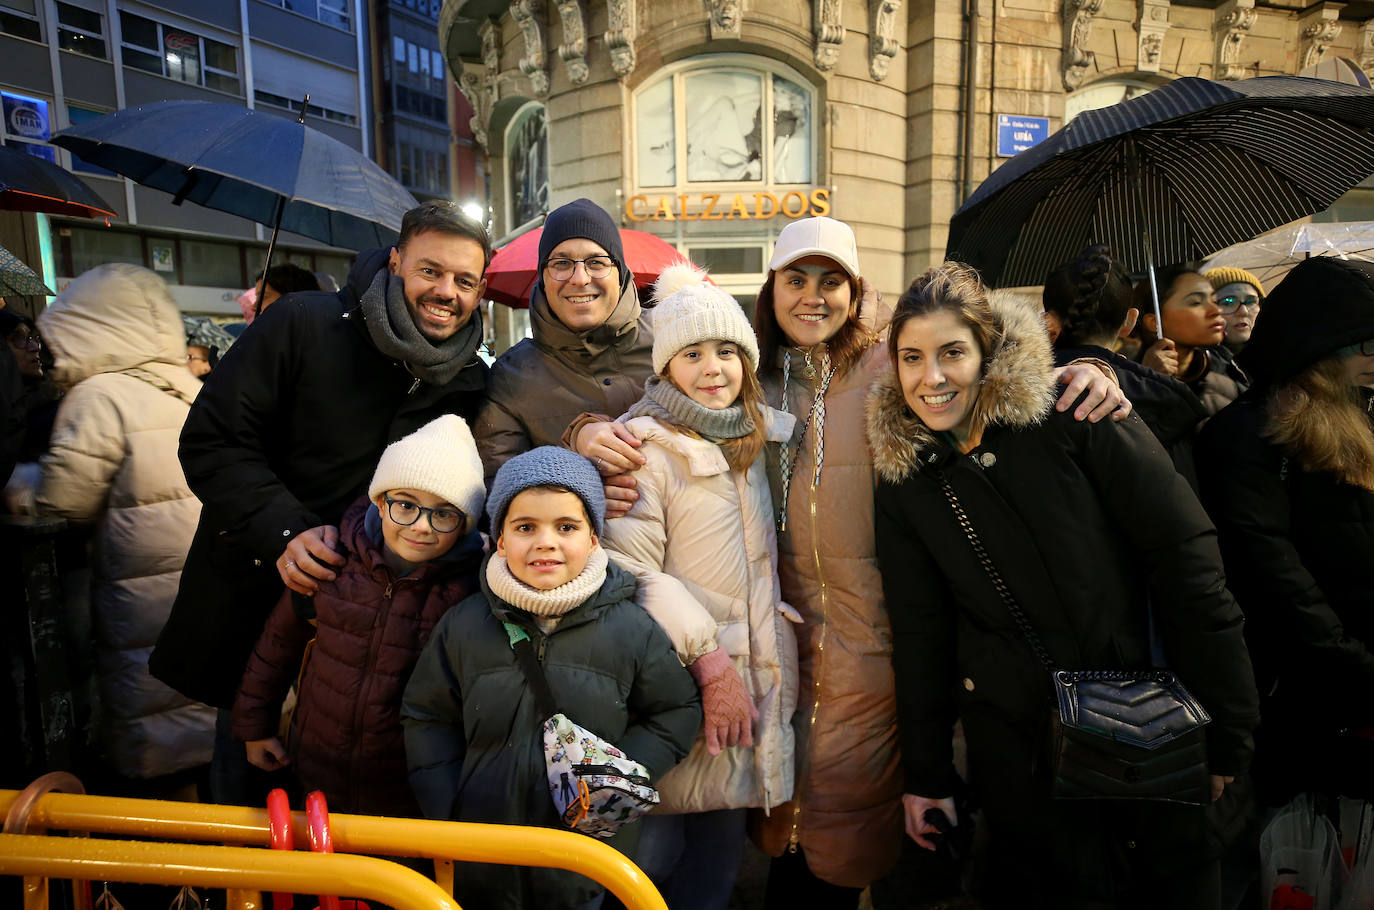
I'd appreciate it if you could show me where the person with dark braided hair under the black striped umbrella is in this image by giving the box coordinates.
[1044,246,1208,489]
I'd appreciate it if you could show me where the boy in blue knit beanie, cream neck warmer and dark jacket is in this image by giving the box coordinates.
[401,447,701,910]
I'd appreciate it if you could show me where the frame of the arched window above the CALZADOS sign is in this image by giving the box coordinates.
[625,54,823,195]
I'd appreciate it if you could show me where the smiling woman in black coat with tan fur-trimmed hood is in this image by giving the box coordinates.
[868,263,1257,907]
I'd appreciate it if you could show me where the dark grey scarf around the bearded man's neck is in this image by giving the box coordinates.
[361,265,482,386]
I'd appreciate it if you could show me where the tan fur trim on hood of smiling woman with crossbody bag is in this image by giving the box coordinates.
[867,293,1054,482]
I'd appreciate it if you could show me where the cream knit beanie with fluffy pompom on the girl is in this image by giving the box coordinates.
[653,263,758,373]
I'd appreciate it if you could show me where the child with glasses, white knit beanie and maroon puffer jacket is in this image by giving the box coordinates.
[225,415,485,817]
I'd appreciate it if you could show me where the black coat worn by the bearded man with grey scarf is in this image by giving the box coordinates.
[148,249,486,708]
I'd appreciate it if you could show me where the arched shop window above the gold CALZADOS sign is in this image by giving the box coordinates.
[633,55,816,187]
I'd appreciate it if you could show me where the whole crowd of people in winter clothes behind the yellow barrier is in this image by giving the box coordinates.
[0,193,1374,910]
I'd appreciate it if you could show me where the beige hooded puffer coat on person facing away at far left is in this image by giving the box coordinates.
[38,265,214,778]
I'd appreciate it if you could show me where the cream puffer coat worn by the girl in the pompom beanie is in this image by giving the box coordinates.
[602,412,797,814]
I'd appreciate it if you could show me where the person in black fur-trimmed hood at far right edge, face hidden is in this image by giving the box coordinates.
[1197,257,1374,803]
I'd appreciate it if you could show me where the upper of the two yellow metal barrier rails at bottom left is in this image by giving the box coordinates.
[0,790,668,910]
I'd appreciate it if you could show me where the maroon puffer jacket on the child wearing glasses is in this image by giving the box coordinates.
[234,498,482,817]
